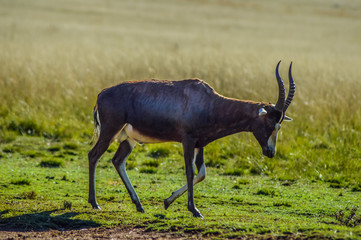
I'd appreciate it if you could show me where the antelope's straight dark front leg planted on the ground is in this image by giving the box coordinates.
[183,140,203,218]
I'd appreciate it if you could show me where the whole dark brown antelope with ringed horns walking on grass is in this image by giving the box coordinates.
[88,61,295,218]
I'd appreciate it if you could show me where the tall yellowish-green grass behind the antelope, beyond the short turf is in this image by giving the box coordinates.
[0,0,361,181]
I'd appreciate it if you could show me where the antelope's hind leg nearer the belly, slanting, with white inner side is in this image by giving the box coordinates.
[112,139,144,212]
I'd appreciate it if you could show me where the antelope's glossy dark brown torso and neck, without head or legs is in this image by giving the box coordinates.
[97,79,262,148]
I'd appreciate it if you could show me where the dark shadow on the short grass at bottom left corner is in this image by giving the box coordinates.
[0,210,100,232]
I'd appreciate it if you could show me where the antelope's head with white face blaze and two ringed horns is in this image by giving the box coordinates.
[252,61,295,158]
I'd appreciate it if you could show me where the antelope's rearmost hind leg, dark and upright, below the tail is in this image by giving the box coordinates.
[88,128,114,209]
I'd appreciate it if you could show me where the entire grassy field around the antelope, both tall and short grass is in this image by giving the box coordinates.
[0,0,361,238]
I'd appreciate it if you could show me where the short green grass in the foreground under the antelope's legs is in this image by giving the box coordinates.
[0,137,361,239]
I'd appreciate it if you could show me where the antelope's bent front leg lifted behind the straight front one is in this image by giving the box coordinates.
[164,148,206,209]
